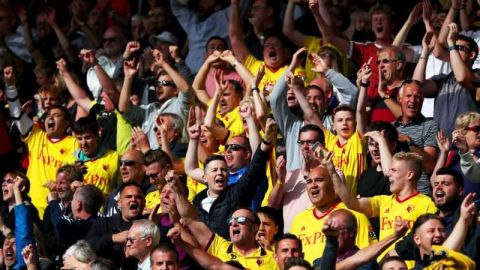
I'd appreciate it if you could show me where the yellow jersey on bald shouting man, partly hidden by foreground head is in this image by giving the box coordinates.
[290,202,377,263]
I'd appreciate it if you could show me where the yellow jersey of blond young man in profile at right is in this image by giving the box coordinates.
[368,192,438,259]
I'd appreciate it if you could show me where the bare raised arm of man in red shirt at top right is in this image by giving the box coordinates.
[308,0,350,54]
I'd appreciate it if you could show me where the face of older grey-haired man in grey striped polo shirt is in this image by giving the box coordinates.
[400,83,423,120]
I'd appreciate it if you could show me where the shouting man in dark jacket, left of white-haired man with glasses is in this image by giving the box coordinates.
[85,182,145,269]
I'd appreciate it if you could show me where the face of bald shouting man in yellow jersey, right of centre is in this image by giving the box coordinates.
[306,167,335,207]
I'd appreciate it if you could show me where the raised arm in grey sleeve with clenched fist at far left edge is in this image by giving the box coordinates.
[3,66,33,136]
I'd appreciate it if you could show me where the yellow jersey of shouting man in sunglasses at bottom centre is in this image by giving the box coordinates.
[207,235,279,270]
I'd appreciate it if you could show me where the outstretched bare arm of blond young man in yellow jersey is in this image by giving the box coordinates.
[322,152,373,217]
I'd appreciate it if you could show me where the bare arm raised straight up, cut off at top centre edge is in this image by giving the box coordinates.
[228,0,250,63]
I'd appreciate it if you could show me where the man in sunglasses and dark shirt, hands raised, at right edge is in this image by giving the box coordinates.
[413,23,480,137]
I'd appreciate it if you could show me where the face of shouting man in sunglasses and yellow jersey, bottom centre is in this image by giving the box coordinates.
[229,209,258,246]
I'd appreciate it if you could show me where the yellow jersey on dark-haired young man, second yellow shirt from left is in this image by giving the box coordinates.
[65,150,120,195]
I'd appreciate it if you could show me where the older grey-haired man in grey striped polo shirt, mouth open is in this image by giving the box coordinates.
[393,80,436,195]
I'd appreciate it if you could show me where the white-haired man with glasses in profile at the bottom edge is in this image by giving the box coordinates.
[125,219,160,270]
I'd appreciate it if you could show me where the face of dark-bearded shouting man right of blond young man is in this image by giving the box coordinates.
[433,174,463,209]
